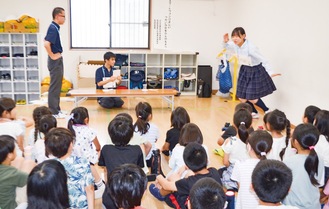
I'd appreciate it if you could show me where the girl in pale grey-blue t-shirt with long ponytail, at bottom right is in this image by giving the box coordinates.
[283,124,324,209]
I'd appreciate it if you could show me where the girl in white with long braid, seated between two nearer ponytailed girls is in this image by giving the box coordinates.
[264,109,296,161]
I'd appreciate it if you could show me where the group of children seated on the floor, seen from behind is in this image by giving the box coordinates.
[0,95,329,209]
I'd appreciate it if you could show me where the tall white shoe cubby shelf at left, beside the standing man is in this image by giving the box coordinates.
[0,33,41,105]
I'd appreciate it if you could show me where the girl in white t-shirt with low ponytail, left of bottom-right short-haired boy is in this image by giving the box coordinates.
[231,130,273,209]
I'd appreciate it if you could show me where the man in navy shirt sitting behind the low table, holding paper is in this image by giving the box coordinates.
[95,52,124,108]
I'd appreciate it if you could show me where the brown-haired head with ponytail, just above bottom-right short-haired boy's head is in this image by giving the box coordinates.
[247,130,273,160]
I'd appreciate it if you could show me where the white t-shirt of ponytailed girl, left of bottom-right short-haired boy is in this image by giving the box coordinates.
[231,158,259,209]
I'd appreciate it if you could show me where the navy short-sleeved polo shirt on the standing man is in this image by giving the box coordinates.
[45,21,63,54]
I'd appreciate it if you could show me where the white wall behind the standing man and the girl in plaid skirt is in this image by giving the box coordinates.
[0,0,329,124]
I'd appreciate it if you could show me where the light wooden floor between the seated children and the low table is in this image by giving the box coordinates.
[17,96,262,209]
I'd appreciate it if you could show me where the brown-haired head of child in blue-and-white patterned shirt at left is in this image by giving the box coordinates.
[45,127,74,158]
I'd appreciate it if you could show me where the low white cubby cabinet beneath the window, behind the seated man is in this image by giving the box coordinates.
[116,53,198,95]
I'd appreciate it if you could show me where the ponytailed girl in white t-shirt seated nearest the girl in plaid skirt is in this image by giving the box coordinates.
[220,109,252,189]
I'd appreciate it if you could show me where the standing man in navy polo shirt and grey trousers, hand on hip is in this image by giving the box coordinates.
[44,7,65,118]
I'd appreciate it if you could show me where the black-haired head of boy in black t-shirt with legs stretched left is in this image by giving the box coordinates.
[183,142,208,172]
